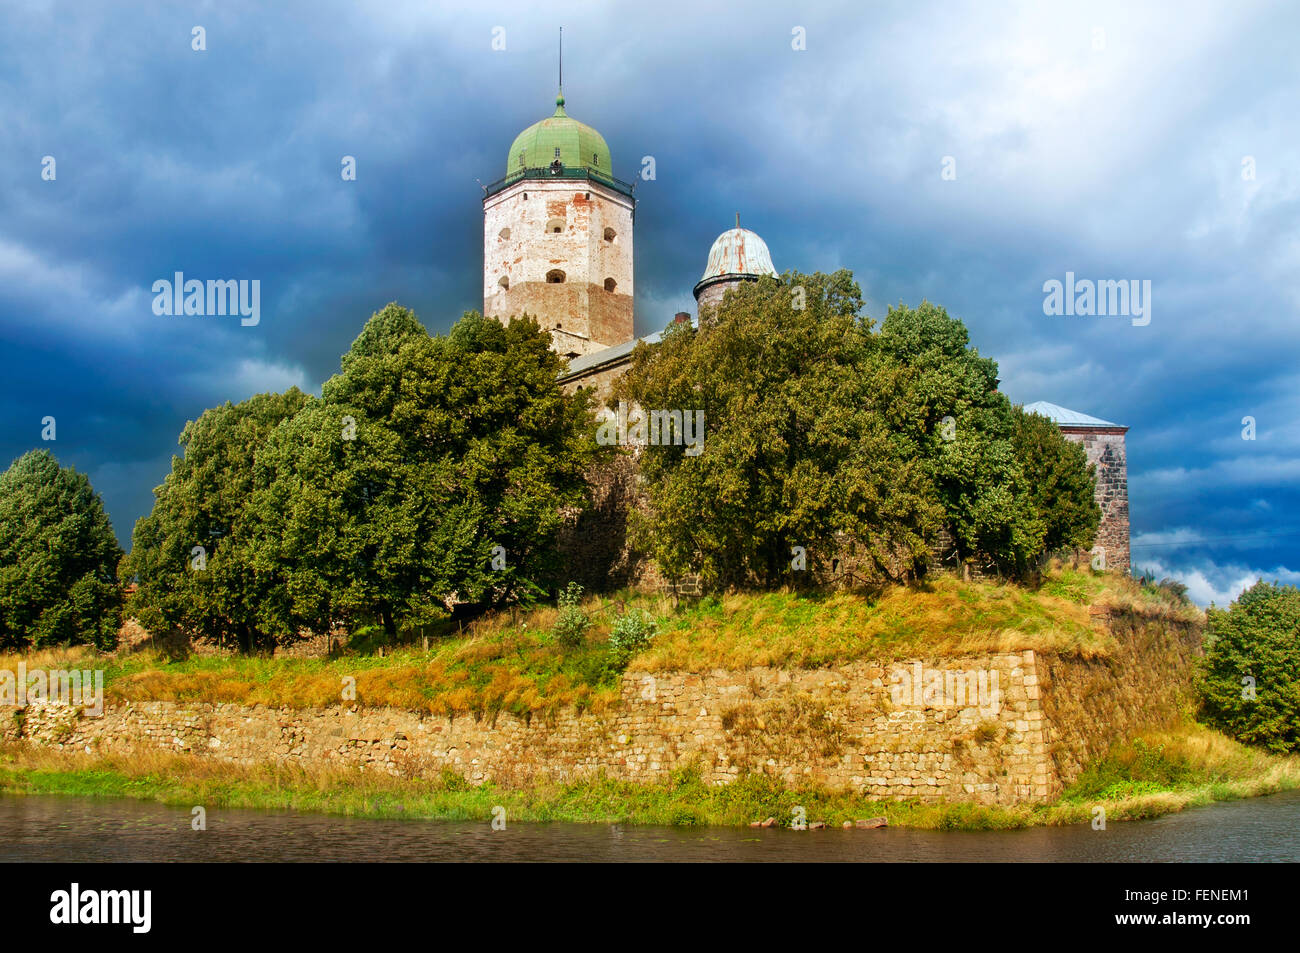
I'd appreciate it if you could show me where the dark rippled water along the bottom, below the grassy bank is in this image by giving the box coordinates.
[0,792,1300,863]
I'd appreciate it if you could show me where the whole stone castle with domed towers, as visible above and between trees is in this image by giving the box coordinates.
[484,92,1128,584]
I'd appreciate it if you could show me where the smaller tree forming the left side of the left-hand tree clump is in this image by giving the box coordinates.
[122,387,307,651]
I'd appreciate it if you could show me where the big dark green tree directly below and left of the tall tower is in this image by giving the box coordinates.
[250,304,593,637]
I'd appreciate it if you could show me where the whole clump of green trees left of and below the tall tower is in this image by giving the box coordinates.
[124,304,592,651]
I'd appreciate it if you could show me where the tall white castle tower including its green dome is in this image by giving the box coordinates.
[484,92,636,358]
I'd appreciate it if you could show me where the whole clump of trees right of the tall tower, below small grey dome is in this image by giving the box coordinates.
[618,270,1100,579]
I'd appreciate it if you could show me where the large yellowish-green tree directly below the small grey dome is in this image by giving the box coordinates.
[619,270,941,586]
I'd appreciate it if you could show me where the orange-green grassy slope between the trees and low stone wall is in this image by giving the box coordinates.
[0,567,1199,714]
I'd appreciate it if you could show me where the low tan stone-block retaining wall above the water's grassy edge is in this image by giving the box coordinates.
[0,608,1200,805]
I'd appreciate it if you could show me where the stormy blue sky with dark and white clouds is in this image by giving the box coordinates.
[0,0,1300,605]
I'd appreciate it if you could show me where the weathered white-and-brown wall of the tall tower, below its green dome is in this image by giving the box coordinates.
[484,179,633,355]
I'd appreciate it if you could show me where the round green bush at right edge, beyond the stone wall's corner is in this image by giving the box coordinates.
[1197,580,1300,753]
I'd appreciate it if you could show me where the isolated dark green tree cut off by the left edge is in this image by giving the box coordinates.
[0,450,122,649]
